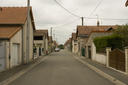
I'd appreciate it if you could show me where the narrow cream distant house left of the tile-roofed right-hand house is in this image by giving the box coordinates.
[72,33,78,53]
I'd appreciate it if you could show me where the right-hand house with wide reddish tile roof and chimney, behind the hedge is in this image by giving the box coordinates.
[76,24,117,59]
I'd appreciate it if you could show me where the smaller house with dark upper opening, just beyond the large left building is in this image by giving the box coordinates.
[34,30,49,58]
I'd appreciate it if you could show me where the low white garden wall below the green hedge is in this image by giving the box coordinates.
[92,43,107,65]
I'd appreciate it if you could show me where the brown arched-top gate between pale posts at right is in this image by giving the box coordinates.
[109,49,125,72]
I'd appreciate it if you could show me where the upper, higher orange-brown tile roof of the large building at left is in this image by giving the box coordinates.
[0,7,35,29]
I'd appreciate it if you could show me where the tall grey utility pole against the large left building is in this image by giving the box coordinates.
[26,0,30,63]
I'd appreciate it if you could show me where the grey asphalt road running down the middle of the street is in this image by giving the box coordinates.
[10,51,114,85]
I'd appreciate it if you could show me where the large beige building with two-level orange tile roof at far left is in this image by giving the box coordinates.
[0,7,35,69]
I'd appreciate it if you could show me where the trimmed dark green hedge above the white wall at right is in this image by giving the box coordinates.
[93,35,123,53]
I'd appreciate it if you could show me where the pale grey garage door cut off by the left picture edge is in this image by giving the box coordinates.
[0,42,5,71]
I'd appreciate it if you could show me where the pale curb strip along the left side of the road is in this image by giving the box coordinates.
[0,57,47,85]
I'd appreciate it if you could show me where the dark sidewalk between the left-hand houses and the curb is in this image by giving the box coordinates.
[0,57,44,82]
